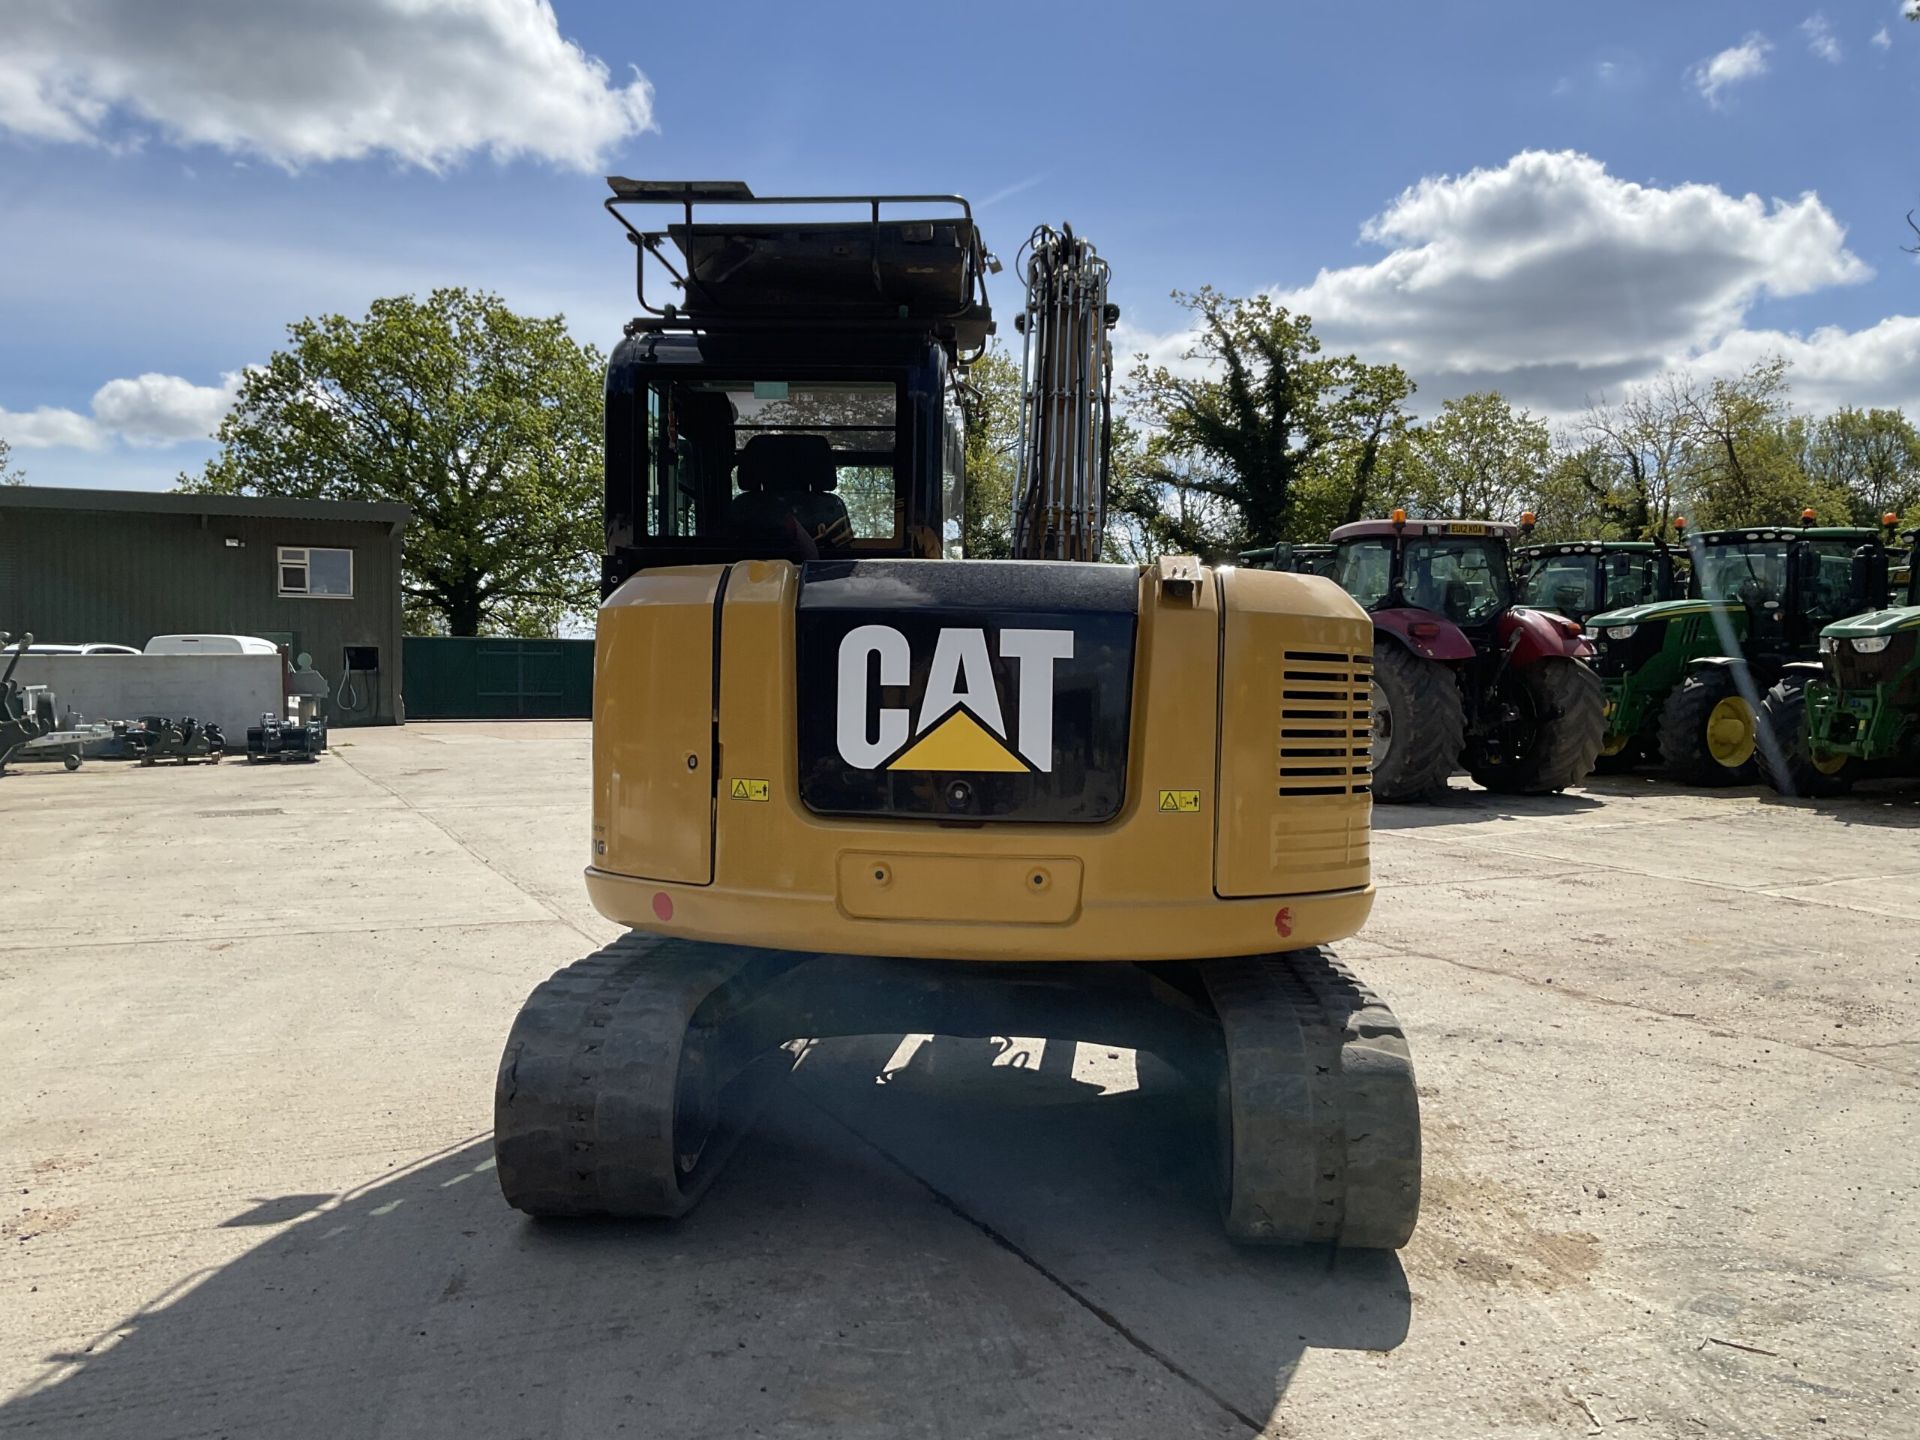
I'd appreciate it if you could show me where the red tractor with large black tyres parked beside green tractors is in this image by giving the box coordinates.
[1332,511,1607,803]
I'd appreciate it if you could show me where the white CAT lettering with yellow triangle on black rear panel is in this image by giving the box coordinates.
[835,624,1073,774]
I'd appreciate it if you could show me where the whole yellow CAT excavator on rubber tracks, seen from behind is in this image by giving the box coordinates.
[493,179,1419,1248]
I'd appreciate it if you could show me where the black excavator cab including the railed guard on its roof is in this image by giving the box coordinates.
[603,177,995,593]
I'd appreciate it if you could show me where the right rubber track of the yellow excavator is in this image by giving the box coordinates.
[1200,950,1421,1250]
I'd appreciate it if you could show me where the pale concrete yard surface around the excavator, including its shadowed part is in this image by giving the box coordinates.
[0,724,1920,1440]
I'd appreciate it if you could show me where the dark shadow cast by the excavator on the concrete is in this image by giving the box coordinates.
[0,1037,1409,1440]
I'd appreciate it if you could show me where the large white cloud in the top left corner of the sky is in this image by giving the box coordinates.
[0,0,653,169]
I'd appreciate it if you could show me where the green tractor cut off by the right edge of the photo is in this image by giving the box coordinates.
[1763,530,1920,795]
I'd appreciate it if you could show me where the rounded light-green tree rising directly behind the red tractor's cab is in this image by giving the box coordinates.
[1411,390,1553,520]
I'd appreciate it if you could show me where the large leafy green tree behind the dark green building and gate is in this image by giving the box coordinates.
[180,290,603,636]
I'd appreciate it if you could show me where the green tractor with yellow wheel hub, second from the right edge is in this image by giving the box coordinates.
[1588,511,1887,785]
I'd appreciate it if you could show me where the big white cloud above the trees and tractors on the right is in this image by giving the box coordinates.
[1116,152,1920,417]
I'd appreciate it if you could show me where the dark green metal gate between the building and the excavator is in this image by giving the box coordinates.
[401,636,593,720]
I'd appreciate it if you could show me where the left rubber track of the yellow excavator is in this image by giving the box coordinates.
[493,935,764,1217]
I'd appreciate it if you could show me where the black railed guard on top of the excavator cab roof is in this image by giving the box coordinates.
[603,175,998,351]
